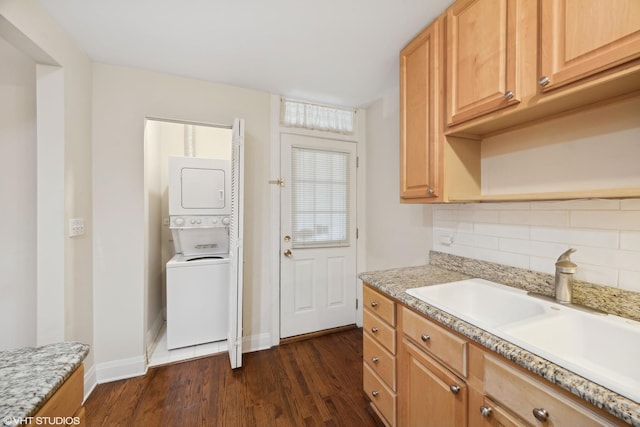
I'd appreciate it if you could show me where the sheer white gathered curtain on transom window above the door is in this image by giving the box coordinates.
[280,98,356,134]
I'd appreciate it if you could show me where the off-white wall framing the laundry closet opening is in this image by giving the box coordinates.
[93,64,271,381]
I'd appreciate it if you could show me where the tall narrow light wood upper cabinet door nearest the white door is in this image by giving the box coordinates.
[400,20,441,199]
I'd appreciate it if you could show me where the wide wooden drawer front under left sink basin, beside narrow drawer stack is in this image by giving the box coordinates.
[402,308,468,377]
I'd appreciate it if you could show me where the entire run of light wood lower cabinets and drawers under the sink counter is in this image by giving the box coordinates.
[363,294,628,427]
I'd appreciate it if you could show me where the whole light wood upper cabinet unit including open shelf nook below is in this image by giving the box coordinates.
[400,0,640,203]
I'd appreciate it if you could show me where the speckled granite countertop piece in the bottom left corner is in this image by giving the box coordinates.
[0,342,89,425]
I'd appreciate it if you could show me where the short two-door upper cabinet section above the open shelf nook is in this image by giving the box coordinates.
[445,0,640,140]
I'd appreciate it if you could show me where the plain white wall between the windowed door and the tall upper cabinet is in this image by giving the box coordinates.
[366,90,432,270]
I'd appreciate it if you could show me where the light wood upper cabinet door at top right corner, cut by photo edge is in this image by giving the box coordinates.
[540,0,640,90]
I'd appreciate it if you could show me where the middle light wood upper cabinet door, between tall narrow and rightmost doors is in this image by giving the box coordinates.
[447,0,521,126]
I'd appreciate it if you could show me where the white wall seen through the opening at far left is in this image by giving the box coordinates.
[0,37,37,350]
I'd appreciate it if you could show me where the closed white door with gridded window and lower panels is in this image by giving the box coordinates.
[280,133,357,338]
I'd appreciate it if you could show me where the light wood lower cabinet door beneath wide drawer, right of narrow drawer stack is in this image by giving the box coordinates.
[398,339,468,427]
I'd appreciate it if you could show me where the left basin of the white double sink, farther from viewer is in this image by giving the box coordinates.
[407,279,548,328]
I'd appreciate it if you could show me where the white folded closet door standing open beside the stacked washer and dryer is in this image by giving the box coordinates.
[227,119,244,369]
